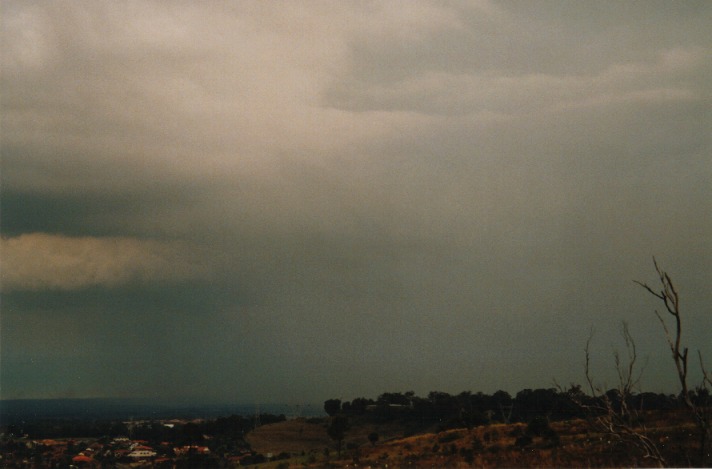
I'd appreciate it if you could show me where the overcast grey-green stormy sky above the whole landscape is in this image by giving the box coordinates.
[0,0,712,403]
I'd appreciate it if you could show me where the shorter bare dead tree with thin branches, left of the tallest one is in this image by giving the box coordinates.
[574,322,667,467]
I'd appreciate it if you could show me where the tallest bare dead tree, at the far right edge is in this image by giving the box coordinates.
[635,258,712,467]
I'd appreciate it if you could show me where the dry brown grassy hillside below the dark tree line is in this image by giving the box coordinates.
[239,414,695,468]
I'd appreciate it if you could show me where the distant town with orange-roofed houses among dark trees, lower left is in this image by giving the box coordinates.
[0,403,287,468]
